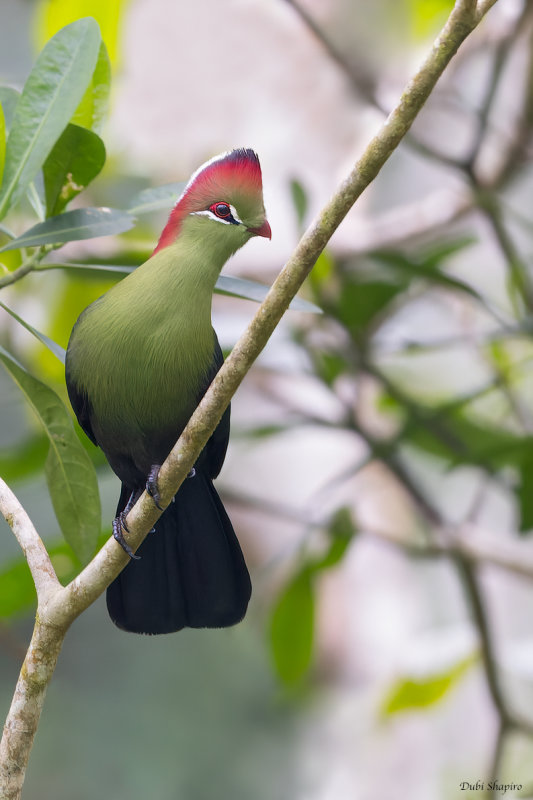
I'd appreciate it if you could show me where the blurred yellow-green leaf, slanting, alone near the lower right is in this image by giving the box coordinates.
[382,656,476,716]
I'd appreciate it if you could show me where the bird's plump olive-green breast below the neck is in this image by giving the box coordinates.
[67,248,215,438]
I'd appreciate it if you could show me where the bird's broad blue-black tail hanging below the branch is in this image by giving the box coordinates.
[107,470,252,633]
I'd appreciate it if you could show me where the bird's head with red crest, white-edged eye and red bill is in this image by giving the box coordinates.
[154,149,272,254]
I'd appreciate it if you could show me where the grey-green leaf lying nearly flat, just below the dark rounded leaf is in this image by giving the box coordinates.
[0,208,134,253]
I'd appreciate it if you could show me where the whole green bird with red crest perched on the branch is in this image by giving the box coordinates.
[66,149,271,634]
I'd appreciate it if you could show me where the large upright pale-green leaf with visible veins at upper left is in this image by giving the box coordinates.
[0,18,100,219]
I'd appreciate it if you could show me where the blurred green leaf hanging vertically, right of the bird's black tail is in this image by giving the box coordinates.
[270,568,315,687]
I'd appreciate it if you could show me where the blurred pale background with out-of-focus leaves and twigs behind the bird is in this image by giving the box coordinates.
[0,0,533,800]
